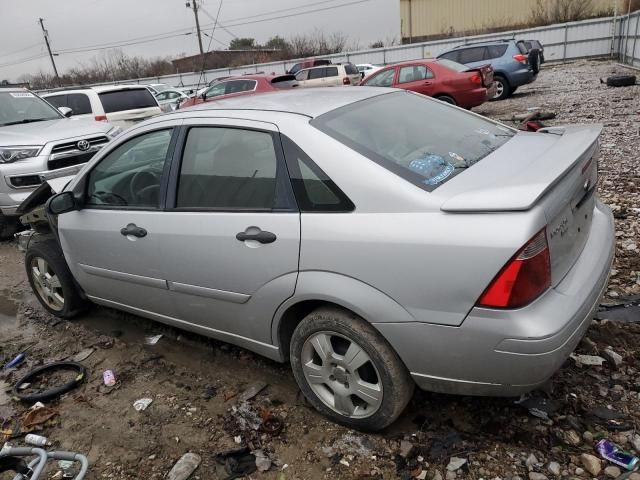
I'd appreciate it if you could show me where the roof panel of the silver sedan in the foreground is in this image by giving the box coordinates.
[177,87,390,118]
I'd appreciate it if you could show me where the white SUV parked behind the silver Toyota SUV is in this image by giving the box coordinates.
[42,85,162,127]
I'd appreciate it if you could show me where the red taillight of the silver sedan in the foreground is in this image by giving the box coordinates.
[477,229,551,308]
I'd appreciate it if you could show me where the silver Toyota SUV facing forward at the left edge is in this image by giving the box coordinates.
[0,88,122,239]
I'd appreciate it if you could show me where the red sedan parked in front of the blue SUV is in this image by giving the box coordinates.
[360,59,495,108]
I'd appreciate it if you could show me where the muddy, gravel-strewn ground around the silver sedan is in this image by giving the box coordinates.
[0,61,640,480]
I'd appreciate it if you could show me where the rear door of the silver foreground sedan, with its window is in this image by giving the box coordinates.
[155,119,300,347]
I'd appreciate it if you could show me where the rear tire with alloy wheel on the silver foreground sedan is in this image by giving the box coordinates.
[290,307,415,431]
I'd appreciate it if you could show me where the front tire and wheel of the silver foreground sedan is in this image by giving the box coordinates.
[24,239,89,318]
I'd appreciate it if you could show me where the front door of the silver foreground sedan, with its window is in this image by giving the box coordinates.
[58,122,176,315]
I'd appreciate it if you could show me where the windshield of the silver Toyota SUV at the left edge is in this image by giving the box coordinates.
[0,92,64,127]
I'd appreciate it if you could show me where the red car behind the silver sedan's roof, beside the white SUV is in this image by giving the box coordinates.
[180,74,298,109]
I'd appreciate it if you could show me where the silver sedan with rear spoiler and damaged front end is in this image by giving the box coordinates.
[24,88,614,430]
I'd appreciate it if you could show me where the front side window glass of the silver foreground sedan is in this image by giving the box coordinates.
[86,129,172,208]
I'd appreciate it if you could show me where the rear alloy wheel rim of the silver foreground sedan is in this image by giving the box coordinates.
[301,331,383,418]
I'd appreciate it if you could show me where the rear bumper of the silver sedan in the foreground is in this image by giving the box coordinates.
[375,201,615,396]
